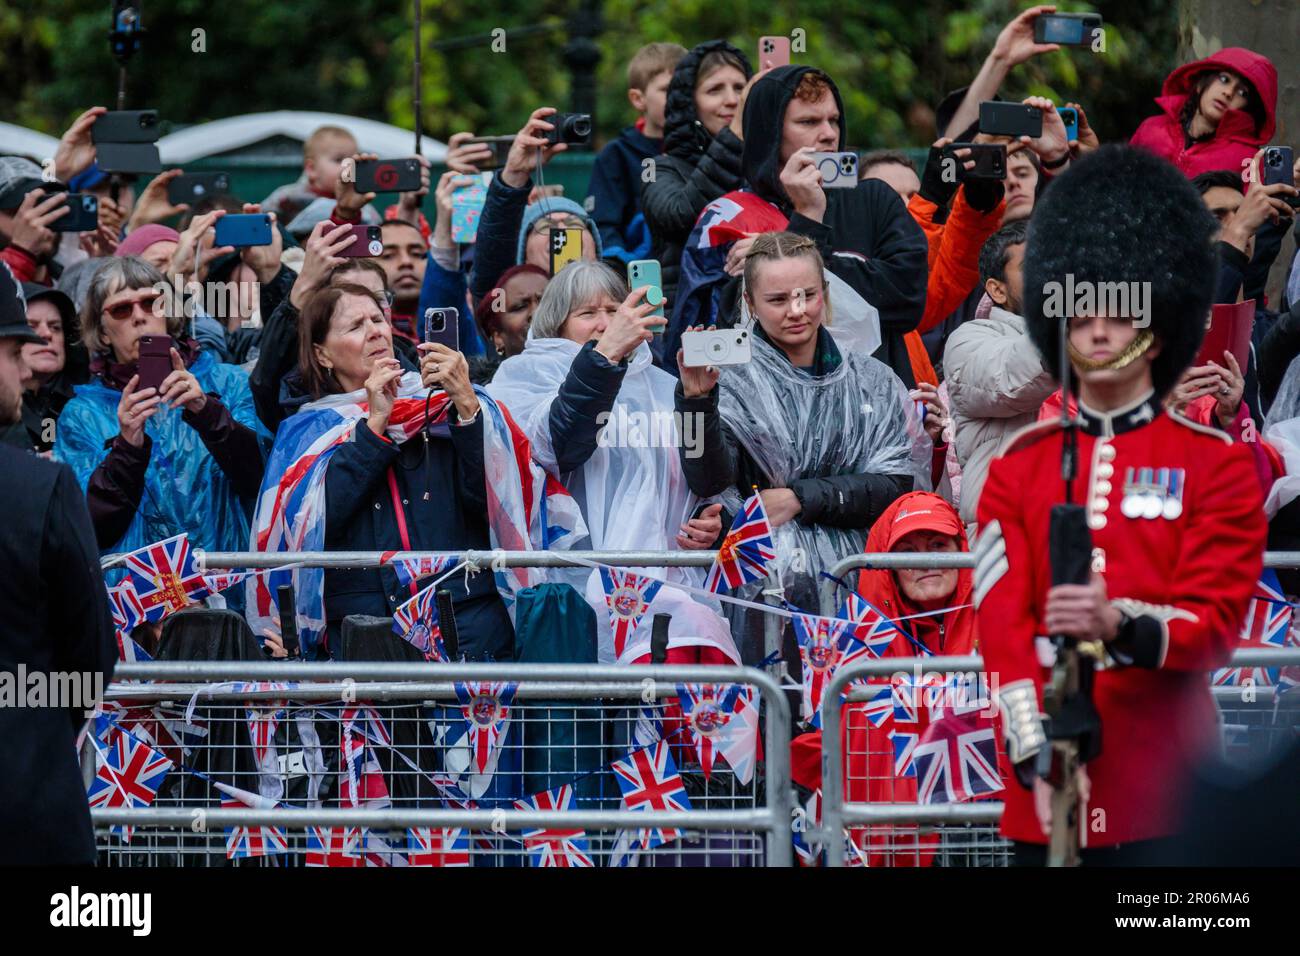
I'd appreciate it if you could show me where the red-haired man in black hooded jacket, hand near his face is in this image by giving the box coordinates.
[728,66,927,388]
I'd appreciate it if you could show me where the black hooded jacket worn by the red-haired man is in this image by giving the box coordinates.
[742,66,928,388]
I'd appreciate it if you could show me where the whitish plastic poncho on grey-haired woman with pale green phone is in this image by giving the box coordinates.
[488,332,740,663]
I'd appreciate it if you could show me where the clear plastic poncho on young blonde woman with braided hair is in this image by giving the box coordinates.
[719,329,933,629]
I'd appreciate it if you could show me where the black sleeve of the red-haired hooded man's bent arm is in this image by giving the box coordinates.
[788,179,930,337]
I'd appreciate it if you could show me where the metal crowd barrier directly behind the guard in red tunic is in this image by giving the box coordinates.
[809,650,1300,866]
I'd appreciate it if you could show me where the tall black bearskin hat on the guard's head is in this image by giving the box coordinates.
[1024,146,1218,398]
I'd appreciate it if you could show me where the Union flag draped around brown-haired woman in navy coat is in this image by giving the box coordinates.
[247,372,586,650]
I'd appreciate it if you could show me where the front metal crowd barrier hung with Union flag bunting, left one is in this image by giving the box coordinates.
[83,661,792,866]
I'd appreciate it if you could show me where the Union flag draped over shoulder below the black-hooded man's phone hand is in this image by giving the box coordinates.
[663,191,789,361]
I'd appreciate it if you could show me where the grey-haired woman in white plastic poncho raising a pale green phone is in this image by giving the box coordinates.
[488,261,740,663]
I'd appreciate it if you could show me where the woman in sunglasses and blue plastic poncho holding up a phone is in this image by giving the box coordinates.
[55,256,269,553]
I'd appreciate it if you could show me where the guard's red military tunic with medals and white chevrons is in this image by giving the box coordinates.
[975,398,1266,847]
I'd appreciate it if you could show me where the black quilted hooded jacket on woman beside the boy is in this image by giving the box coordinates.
[641,40,751,311]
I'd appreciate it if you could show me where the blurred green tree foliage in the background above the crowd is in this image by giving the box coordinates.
[0,0,1177,148]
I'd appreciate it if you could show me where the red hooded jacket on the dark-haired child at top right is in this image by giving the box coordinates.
[1130,47,1278,178]
